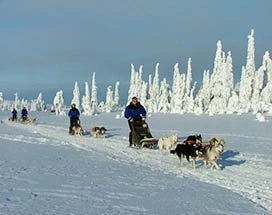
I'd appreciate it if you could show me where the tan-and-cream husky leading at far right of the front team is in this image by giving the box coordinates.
[199,137,225,169]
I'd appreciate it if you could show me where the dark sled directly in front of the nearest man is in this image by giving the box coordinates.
[129,120,158,149]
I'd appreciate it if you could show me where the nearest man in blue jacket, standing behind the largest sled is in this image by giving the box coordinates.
[124,96,146,146]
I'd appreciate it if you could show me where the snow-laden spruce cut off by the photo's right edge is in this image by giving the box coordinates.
[260,51,272,113]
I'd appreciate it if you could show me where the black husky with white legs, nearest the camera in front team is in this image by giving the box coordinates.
[170,143,202,169]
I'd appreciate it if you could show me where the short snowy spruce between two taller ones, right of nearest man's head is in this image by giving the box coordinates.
[158,78,170,113]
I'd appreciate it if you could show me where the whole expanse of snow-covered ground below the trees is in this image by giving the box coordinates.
[0,112,272,215]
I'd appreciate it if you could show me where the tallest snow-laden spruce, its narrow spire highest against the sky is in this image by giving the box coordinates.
[239,29,256,112]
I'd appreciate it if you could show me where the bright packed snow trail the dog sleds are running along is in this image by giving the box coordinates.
[2,117,272,211]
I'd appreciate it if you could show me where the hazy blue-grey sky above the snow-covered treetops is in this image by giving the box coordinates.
[0,0,272,103]
